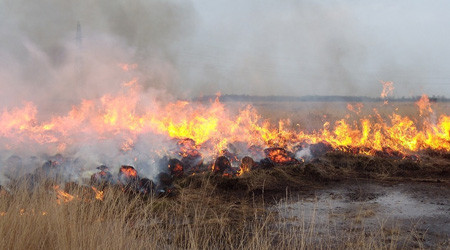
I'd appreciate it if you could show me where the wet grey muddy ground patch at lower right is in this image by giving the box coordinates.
[276,181,450,248]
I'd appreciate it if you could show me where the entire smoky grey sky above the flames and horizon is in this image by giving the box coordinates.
[0,0,450,106]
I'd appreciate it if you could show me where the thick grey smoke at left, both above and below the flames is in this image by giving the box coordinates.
[0,0,195,180]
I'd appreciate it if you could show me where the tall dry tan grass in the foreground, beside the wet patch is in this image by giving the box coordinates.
[0,177,432,249]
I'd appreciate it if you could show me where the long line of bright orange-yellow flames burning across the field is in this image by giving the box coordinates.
[0,79,450,160]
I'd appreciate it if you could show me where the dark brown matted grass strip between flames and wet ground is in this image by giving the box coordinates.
[175,151,450,197]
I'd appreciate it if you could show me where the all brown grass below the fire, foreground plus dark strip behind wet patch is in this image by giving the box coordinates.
[0,151,450,249]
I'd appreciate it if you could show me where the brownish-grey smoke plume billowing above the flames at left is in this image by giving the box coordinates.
[0,0,194,110]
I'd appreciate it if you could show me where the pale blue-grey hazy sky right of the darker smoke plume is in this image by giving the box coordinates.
[179,0,450,97]
